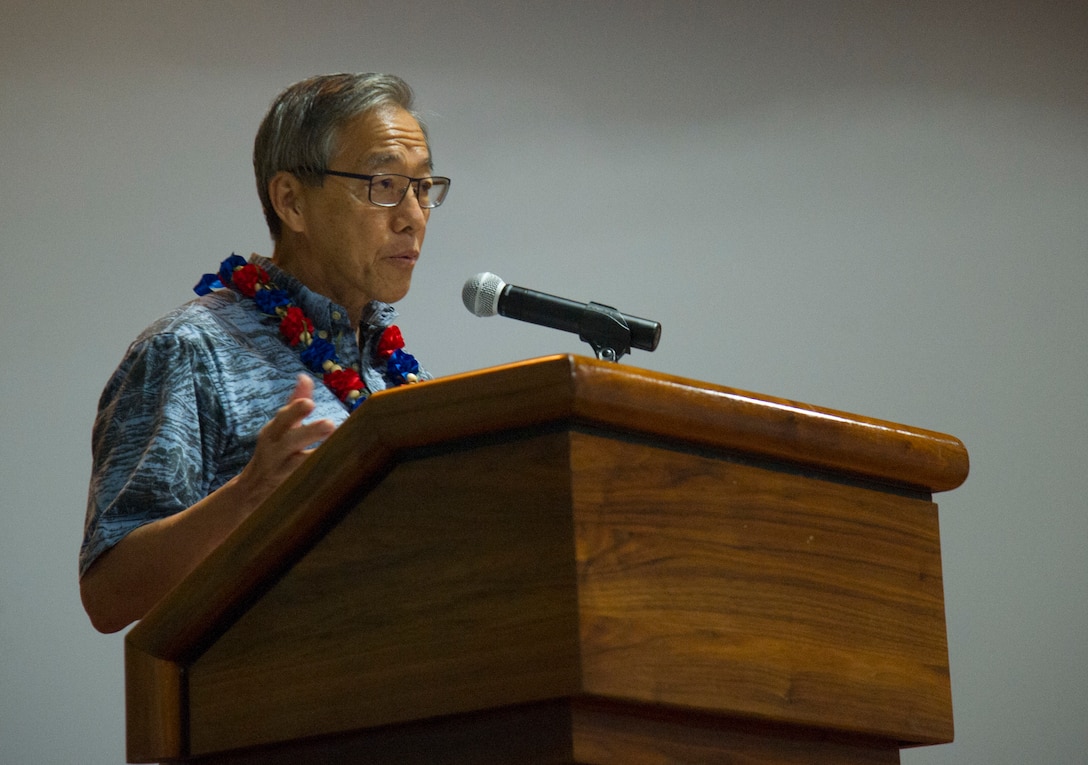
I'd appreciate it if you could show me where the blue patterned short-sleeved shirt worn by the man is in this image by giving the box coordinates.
[79,256,430,577]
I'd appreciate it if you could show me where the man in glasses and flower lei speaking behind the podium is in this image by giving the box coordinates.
[79,74,449,632]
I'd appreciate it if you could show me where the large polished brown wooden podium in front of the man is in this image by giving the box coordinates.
[125,356,967,765]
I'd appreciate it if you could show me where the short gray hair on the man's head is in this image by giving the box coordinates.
[254,73,426,239]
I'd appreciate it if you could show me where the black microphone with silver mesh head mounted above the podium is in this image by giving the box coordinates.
[461,272,662,358]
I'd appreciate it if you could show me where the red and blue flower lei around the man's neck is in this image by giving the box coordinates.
[193,254,419,410]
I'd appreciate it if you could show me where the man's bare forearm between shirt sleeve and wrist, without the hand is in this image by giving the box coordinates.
[79,477,257,632]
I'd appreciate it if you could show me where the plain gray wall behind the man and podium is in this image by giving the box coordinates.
[0,0,1088,765]
